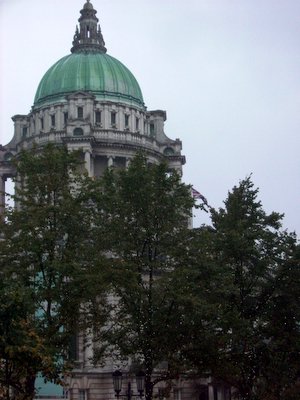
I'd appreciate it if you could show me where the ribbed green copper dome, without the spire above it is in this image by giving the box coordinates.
[34,51,144,108]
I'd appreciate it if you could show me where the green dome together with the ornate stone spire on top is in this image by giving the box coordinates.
[33,0,145,109]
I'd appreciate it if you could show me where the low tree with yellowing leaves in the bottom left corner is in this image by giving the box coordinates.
[0,274,52,399]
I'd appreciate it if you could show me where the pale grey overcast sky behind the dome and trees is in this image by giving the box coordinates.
[0,0,300,233]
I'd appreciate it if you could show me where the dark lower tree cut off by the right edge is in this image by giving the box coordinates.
[261,245,300,400]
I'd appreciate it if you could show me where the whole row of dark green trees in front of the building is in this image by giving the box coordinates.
[0,145,300,400]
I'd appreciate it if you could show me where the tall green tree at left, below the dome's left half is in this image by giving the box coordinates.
[0,145,100,399]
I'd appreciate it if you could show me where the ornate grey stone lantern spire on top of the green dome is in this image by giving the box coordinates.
[71,0,106,53]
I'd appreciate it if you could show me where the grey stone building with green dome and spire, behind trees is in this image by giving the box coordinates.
[0,0,229,400]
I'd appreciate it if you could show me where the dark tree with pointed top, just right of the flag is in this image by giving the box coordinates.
[200,177,299,400]
